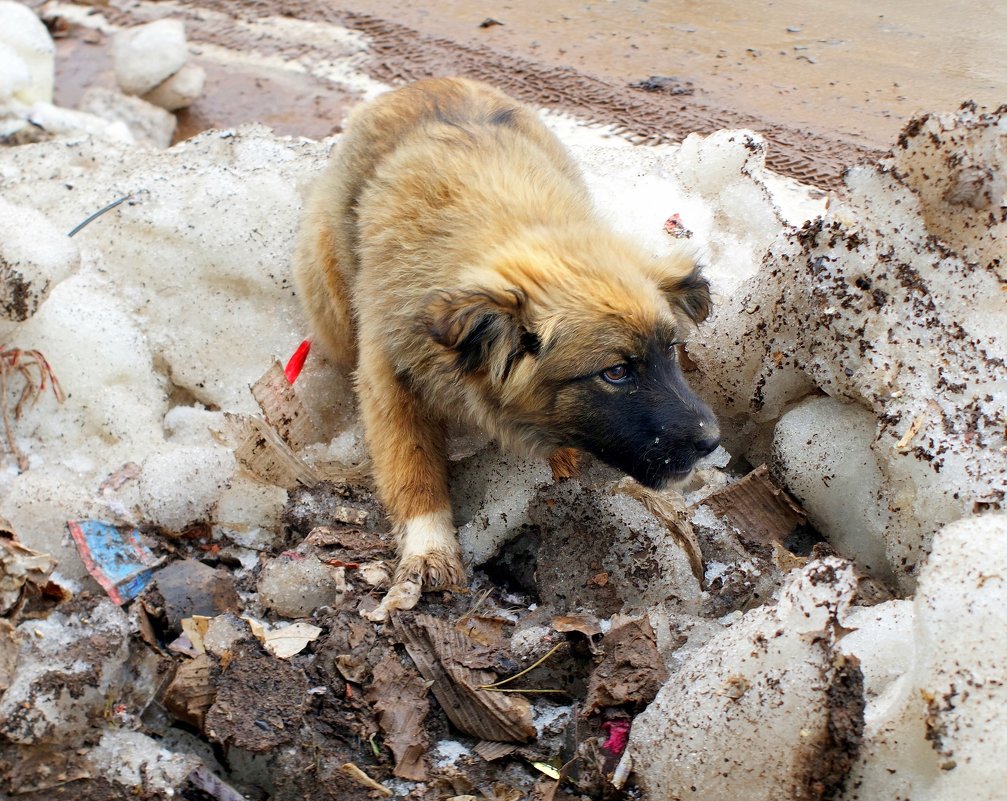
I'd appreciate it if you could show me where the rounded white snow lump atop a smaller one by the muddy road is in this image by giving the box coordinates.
[112,19,188,95]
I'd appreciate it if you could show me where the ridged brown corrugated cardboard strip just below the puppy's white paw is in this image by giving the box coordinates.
[393,615,536,743]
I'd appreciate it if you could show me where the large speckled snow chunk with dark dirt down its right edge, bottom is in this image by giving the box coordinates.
[628,559,862,801]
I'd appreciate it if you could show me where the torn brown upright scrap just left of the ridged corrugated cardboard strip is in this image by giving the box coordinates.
[367,653,430,782]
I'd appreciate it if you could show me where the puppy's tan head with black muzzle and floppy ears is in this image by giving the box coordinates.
[427,234,720,488]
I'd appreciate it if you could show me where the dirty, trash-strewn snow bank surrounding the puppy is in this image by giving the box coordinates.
[0,3,1007,801]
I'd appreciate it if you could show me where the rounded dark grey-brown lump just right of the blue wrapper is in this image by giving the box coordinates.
[153,559,241,632]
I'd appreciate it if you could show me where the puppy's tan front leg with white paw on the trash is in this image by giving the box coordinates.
[356,349,465,589]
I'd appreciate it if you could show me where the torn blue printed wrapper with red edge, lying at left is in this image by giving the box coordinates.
[66,520,164,606]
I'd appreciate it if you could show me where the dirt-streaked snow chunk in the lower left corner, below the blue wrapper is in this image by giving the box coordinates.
[0,598,129,744]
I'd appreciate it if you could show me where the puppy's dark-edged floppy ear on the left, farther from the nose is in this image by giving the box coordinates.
[427,288,539,381]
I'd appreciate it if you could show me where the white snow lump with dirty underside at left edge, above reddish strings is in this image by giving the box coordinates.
[0,197,81,321]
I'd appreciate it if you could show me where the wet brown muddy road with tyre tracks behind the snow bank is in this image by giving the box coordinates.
[49,0,1007,188]
